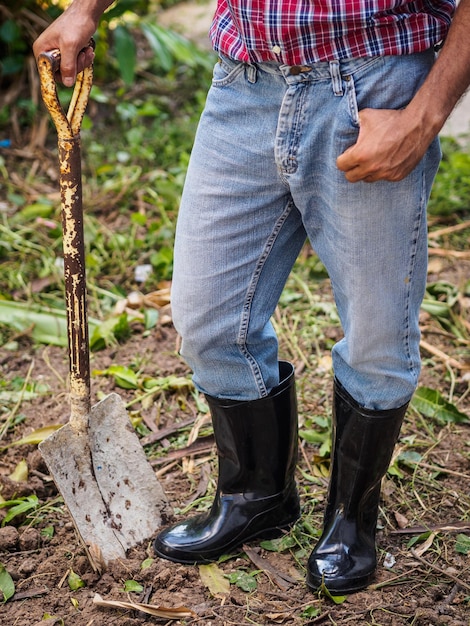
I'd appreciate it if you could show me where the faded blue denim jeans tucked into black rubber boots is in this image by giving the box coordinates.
[172,51,440,410]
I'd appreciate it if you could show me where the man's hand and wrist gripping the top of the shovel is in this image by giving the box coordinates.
[33,0,114,87]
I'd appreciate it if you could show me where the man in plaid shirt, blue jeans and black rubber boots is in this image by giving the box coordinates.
[34,0,470,593]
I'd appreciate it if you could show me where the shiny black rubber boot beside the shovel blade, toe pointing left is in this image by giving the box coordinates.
[154,362,300,563]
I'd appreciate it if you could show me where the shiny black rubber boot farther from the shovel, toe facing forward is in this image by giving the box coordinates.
[307,381,407,595]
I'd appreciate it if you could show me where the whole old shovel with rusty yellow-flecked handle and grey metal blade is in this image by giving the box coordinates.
[38,50,172,571]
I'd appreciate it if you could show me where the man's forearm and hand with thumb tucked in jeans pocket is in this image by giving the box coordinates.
[337,0,470,182]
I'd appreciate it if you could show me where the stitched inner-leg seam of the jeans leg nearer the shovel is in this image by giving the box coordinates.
[237,200,293,397]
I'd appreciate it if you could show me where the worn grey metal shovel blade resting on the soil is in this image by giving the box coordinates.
[39,393,172,564]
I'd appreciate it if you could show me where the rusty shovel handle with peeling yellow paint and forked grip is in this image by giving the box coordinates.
[38,50,93,432]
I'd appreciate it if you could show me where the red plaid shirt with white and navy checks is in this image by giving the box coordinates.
[211,0,455,65]
